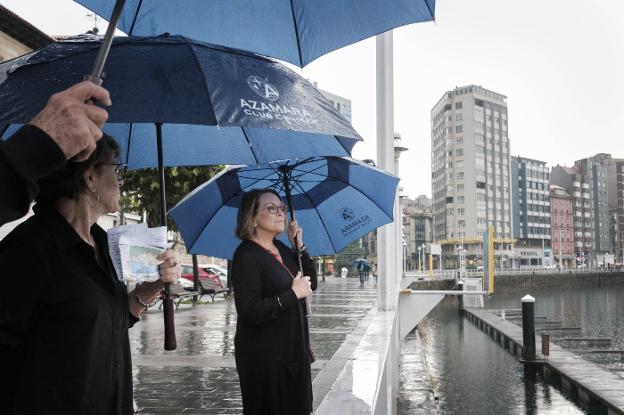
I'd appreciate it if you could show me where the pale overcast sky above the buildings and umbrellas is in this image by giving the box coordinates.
[0,0,624,197]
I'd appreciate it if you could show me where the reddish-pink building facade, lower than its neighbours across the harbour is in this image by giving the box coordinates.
[550,186,576,268]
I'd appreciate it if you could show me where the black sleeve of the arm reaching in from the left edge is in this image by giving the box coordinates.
[0,125,66,225]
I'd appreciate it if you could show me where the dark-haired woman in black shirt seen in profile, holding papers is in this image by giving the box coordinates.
[0,135,180,415]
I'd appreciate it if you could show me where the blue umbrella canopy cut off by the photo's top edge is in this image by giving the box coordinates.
[76,0,436,67]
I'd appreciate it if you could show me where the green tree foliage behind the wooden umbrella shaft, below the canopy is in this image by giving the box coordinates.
[119,166,223,229]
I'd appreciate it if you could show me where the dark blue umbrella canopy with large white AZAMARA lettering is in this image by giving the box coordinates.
[0,35,361,168]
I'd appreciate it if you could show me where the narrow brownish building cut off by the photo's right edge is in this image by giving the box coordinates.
[607,158,624,264]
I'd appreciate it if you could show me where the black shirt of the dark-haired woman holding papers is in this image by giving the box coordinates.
[0,205,137,415]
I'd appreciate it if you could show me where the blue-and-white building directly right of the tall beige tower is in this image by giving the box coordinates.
[511,157,552,267]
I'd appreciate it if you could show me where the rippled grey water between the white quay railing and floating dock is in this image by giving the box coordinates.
[405,297,593,415]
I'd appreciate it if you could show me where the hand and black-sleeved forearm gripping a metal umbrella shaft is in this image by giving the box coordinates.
[0,81,112,225]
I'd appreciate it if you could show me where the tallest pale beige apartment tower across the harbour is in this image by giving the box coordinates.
[431,85,513,268]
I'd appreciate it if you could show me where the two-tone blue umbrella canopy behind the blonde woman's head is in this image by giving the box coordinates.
[170,157,399,258]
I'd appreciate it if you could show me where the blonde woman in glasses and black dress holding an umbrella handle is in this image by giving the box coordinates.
[231,189,317,415]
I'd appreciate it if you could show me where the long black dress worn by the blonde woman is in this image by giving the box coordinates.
[231,240,317,415]
